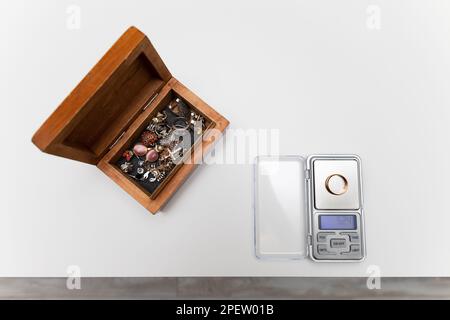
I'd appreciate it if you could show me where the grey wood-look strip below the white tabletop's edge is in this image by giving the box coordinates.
[0,277,450,299]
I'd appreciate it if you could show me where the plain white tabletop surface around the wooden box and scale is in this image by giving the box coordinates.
[0,0,450,276]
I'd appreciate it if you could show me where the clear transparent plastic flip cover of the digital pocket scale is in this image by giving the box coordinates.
[254,156,308,260]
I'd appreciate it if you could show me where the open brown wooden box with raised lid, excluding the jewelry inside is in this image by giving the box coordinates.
[32,27,229,213]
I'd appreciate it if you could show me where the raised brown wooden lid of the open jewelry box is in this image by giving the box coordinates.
[32,27,172,164]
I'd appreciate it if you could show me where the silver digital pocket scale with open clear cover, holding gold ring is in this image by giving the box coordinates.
[254,155,366,262]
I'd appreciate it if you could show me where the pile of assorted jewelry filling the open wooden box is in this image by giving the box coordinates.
[116,97,205,193]
